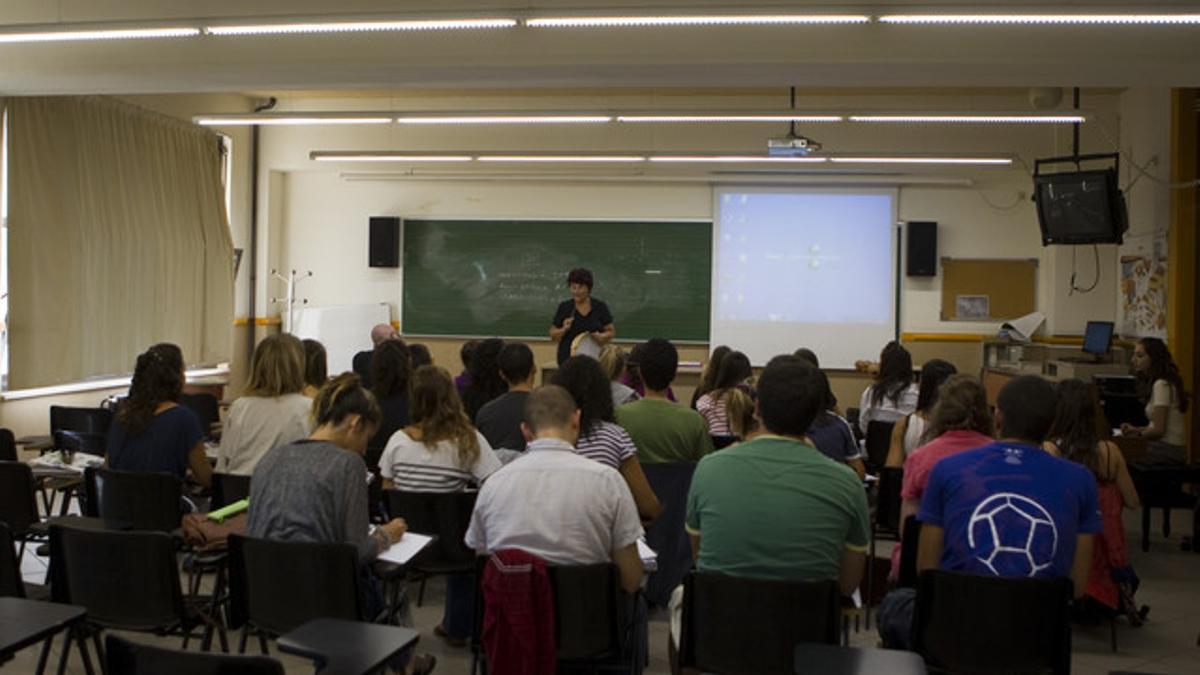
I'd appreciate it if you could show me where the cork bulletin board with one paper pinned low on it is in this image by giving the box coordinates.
[942,258,1038,322]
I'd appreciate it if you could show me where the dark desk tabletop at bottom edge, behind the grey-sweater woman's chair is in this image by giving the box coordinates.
[276,619,420,675]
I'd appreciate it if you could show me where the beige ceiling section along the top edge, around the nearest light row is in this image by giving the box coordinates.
[0,0,1200,95]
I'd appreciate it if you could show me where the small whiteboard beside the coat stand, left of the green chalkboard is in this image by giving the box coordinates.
[292,303,391,377]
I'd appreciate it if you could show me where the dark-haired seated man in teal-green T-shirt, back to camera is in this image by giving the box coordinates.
[671,357,870,644]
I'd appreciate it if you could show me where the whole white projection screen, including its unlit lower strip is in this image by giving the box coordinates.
[710,187,898,368]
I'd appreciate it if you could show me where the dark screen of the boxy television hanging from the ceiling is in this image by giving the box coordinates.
[1033,169,1129,245]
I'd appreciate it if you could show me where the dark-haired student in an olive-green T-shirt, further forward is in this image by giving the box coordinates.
[617,338,713,464]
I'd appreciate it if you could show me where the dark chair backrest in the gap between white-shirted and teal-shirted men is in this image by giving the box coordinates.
[642,461,696,607]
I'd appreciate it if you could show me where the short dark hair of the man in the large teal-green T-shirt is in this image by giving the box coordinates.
[757,356,829,436]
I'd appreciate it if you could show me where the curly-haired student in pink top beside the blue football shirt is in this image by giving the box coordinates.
[890,375,996,579]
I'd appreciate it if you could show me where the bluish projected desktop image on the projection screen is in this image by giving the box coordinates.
[714,192,894,324]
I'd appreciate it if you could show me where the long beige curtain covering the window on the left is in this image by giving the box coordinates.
[4,96,233,389]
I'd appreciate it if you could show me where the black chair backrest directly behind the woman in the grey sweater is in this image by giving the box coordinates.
[229,534,362,635]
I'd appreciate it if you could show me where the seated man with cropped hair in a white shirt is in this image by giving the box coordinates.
[466,384,642,593]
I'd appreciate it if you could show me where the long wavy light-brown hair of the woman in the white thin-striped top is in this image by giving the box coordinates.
[408,365,480,468]
